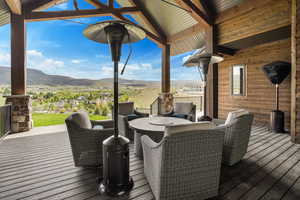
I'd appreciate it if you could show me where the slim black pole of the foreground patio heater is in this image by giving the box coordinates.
[113,61,119,139]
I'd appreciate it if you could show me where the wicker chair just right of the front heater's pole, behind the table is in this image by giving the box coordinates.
[118,102,149,140]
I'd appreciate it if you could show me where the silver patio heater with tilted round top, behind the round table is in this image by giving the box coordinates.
[183,47,224,121]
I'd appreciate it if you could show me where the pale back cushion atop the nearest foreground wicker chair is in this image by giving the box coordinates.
[165,122,216,136]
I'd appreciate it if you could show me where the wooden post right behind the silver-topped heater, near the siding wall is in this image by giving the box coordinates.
[206,26,218,118]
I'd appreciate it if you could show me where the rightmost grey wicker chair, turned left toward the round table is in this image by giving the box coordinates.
[213,113,253,166]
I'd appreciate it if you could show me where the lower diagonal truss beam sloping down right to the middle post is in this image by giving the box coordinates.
[85,0,166,46]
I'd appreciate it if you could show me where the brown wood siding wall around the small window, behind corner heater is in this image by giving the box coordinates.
[218,39,291,129]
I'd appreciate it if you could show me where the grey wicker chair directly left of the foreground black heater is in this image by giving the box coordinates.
[65,112,114,167]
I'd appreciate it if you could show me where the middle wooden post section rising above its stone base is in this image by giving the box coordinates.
[161,44,171,93]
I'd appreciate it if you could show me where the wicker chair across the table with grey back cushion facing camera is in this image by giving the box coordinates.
[163,102,196,122]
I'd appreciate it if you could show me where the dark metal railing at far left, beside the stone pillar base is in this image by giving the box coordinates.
[0,105,12,138]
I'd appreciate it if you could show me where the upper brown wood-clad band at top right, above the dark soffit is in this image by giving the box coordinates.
[217,0,291,45]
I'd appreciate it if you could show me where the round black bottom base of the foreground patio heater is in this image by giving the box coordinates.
[99,178,134,196]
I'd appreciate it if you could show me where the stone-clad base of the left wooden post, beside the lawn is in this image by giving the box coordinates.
[6,95,32,133]
